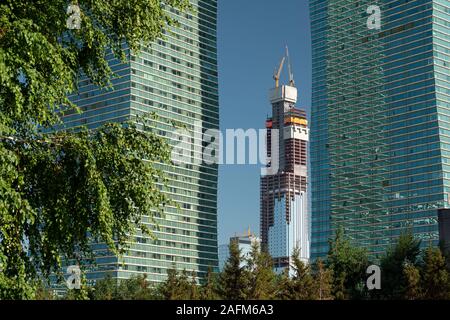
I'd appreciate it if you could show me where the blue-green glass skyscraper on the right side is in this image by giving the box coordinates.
[310,0,450,258]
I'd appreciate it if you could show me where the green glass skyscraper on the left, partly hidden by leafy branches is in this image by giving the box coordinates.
[60,0,219,281]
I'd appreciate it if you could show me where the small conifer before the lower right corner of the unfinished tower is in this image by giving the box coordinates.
[291,248,317,300]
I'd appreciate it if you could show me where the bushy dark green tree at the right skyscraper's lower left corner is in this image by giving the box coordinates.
[326,228,369,300]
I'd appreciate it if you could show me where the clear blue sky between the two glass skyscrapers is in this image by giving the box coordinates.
[218,0,311,244]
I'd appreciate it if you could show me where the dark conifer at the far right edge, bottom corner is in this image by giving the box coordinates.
[422,247,450,300]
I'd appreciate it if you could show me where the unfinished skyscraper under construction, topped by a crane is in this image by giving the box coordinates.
[260,50,310,272]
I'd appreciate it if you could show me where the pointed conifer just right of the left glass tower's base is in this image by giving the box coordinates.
[219,241,249,300]
